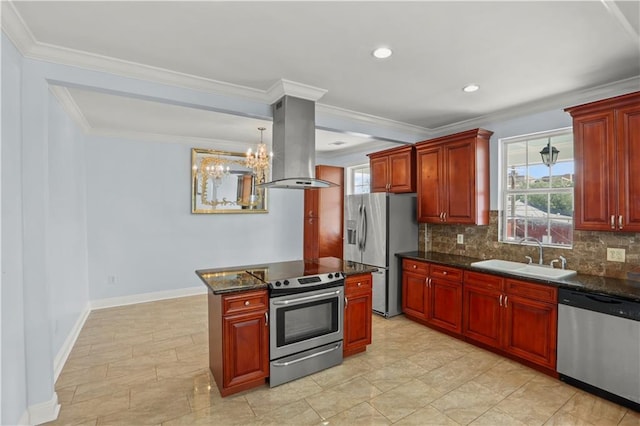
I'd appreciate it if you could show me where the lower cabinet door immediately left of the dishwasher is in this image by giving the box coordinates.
[504,294,558,369]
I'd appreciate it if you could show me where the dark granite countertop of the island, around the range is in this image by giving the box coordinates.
[196,257,378,294]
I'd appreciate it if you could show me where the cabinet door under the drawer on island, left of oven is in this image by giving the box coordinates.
[222,311,269,388]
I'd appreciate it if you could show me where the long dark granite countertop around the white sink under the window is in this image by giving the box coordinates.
[396,251,640,302]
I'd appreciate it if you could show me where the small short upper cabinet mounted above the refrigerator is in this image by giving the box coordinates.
[368,145,416,193]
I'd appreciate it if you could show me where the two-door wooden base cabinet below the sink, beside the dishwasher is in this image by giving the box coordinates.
[462,271,558,371]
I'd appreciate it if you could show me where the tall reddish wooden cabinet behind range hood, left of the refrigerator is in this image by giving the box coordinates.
[303,165,344,259]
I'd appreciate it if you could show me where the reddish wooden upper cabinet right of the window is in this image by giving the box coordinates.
[565,92,640,232]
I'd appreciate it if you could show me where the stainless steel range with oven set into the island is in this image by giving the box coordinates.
[247,259,344,387]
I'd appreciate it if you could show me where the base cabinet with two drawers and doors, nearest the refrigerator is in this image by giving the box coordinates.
[402,259,462,334]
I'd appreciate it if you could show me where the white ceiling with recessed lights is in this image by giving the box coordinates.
[2,0,640,156]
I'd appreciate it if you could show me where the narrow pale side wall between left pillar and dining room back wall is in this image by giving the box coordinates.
[47,95,89,364]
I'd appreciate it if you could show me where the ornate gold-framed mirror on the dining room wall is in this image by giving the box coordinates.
[191,148,268,214]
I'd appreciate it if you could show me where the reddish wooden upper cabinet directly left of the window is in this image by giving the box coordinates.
[416,129,493,225]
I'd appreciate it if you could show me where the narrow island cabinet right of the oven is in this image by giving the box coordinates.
[343,274,373,356]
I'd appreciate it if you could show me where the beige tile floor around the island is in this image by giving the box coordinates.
[46,296,640,426]
